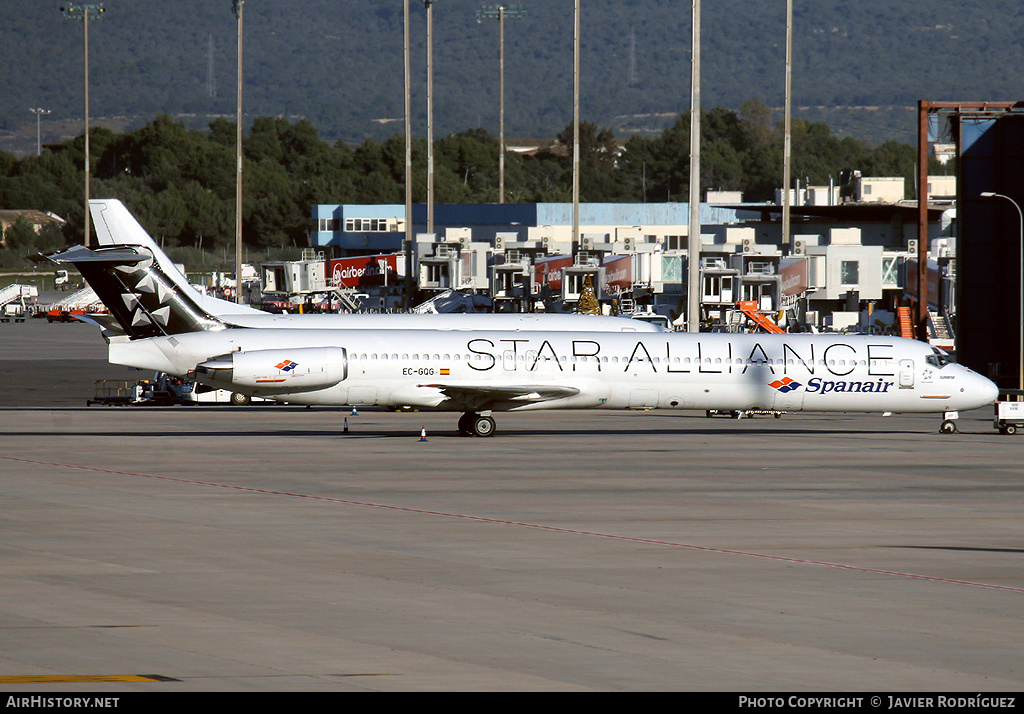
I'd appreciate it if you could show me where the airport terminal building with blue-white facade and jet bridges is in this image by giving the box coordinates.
[311,177,955,330]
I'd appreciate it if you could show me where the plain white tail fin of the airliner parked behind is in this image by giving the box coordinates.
[89,199,259,316]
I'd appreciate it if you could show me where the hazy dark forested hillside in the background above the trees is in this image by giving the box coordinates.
[0,0,1024,153]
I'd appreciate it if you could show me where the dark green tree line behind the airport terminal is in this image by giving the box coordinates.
[0,100,937,266]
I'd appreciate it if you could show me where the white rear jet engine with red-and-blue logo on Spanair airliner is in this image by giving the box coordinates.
[196,347,348,394]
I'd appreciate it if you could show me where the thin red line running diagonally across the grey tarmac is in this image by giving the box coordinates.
[8,456,1024,594]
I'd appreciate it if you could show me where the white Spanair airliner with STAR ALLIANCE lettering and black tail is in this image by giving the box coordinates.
[53,239,997,436]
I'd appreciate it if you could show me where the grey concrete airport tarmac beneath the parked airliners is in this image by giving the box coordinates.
[0,321,1024,692]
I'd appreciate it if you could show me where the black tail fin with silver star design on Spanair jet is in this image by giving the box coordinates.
[50,246,227,339]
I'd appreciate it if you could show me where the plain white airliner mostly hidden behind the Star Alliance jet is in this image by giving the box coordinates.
[89,199,665,332]
